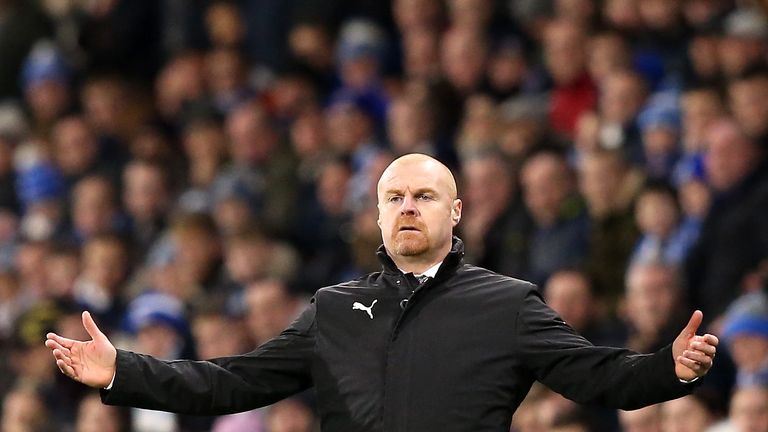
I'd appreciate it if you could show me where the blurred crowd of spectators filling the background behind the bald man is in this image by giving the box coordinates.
[0,0,768,432]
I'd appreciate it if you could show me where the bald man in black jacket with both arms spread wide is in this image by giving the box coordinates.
[46,154,717,432]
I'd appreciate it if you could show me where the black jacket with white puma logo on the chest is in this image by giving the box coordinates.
[102,239,687,432]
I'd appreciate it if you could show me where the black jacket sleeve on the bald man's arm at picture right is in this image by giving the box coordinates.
[516,287,692,410]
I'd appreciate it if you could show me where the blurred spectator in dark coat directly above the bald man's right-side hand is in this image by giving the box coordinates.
[686,119,768,319]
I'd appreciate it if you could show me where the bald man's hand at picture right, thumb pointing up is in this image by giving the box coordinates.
[672,310,720,381]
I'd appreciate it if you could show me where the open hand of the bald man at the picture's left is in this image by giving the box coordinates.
[45,311,117,388]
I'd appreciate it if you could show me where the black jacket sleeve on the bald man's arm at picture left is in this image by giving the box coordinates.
[101,300,316,415]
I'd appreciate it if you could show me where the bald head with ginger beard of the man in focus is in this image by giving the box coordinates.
[377,153,462,271]
